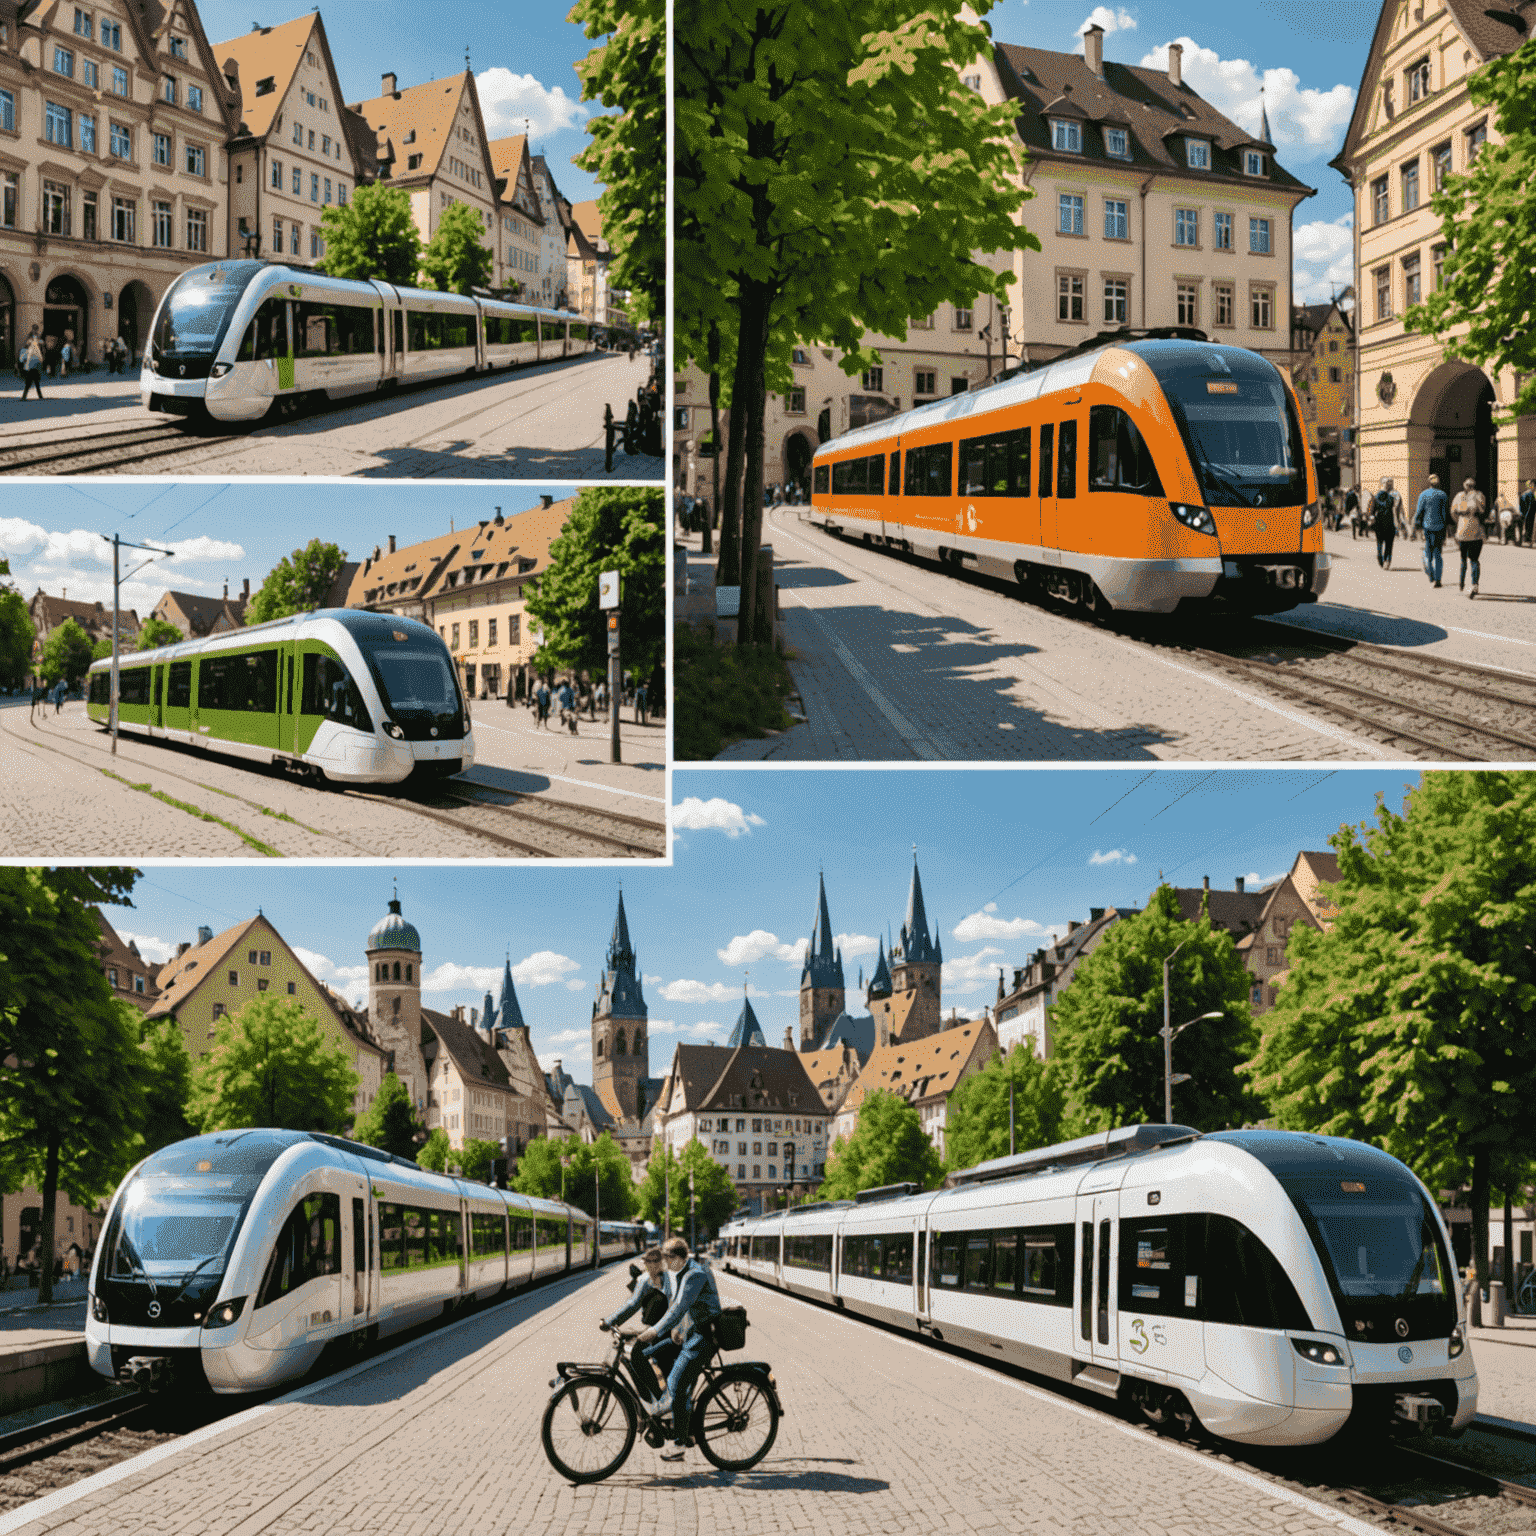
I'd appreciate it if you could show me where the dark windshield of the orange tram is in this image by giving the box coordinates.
[1135,341,1307,507]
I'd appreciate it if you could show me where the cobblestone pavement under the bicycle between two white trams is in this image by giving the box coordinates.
[0,1269,1394,1536]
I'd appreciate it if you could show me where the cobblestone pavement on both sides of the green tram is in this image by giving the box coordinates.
[0,700,665,859]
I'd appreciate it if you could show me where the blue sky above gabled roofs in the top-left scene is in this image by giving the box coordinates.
[198,0,604,203]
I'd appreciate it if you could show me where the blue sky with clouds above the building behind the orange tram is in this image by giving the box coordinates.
[986,0,1381,303]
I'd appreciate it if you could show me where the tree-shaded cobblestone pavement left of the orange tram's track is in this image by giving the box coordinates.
[690,508,1395,762]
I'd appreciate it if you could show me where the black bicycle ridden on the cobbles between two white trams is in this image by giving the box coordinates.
[542,1307,783,1484]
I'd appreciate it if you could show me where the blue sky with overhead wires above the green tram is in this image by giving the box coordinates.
[0,479,574,621]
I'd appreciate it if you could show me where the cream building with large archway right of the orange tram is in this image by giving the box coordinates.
[1332,0,1536,507]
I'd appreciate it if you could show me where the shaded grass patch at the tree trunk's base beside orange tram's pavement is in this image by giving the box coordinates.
[673,624,794,762]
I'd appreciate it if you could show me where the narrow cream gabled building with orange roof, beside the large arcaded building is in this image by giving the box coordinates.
[214,11,357,266]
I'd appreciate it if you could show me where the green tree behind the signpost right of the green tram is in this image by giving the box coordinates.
[527,485,667,677]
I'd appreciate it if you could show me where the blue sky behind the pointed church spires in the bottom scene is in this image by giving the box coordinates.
[108,768,1416,1077]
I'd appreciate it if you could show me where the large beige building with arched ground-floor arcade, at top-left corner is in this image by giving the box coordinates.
[0,0,238,367]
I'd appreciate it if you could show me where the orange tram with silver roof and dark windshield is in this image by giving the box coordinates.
[809,330,1329,613]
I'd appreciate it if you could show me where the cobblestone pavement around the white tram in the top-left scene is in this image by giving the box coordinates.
[0,353,665,481]
